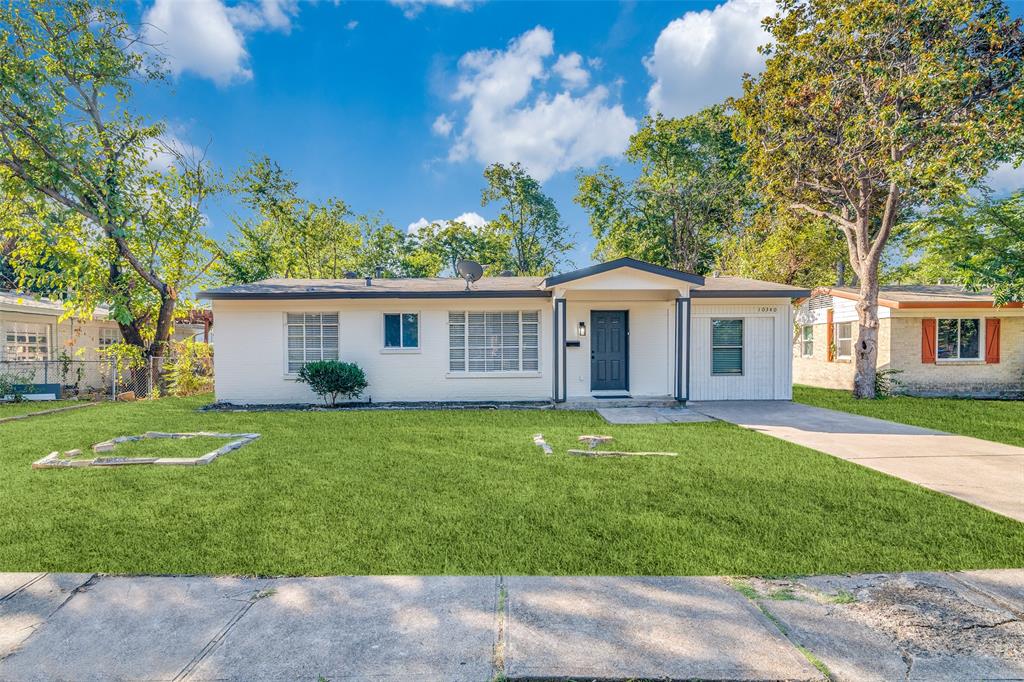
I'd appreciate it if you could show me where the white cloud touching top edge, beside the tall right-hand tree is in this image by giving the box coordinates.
[644,0,776,116]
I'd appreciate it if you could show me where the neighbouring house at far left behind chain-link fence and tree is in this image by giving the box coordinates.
[0,291,212,388]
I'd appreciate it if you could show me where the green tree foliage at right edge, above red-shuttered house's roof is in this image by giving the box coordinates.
[904,187,1024,305]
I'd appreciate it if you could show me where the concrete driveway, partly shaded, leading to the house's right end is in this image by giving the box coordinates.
[689,400,1024,521]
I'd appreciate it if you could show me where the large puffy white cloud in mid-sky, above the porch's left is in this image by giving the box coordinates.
[449,27,636,181]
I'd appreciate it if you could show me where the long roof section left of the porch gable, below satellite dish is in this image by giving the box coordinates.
[200,278,550,299]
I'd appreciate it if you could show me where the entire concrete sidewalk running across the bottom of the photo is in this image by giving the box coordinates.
[0,570,1024,682]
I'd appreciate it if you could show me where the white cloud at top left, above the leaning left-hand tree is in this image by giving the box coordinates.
[142,0,298,85]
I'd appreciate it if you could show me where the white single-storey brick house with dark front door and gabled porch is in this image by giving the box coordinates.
[200,258,810,403]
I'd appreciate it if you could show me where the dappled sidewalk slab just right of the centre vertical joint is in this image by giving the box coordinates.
[505,578,821,680]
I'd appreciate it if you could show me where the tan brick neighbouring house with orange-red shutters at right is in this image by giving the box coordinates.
[793,285,1024,397]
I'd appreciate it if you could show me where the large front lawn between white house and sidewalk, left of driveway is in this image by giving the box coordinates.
[0,398,1024,574]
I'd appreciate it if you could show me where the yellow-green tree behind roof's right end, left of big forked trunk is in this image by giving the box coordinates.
[718,206,847,287]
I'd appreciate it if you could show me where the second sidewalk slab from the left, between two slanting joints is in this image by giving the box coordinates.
[0,577,265,681]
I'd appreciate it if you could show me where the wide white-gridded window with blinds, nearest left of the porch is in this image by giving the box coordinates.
[449,310,541,372]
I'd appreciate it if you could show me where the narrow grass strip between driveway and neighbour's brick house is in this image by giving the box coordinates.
[793,386,1024,446]
